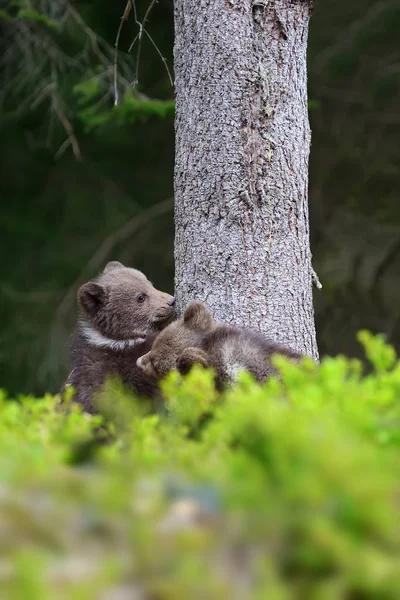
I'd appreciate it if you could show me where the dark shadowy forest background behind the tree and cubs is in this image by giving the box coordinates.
[0,0,400,394]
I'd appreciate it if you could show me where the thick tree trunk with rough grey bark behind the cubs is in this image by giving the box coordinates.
[174,0,318,358]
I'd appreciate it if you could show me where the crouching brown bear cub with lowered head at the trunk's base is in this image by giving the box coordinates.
[137,302,301,390]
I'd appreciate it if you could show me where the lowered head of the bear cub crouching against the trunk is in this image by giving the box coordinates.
[136,302,215,380]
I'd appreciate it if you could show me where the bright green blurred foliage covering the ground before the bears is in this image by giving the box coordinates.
[0,332,400,599]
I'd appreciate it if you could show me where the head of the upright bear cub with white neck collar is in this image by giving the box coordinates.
[78,261,175,341]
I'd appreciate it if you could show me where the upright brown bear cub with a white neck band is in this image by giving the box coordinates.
[66,261,175,412]
